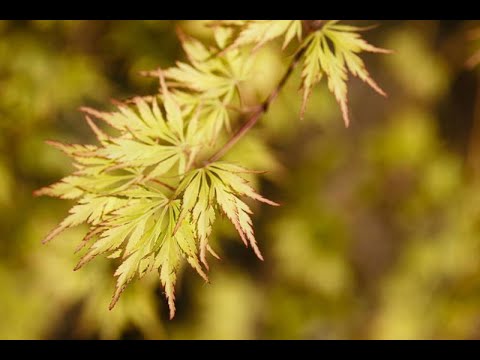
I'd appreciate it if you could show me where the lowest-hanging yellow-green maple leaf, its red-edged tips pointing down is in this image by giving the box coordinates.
[76,187,207,317]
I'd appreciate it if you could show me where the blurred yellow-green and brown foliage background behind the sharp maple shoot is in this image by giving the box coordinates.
[0,20,480,339]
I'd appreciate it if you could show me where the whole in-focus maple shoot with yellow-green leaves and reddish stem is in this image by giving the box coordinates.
[36,20,387,318]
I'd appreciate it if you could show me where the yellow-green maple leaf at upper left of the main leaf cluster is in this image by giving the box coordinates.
[84,88,201,179]
